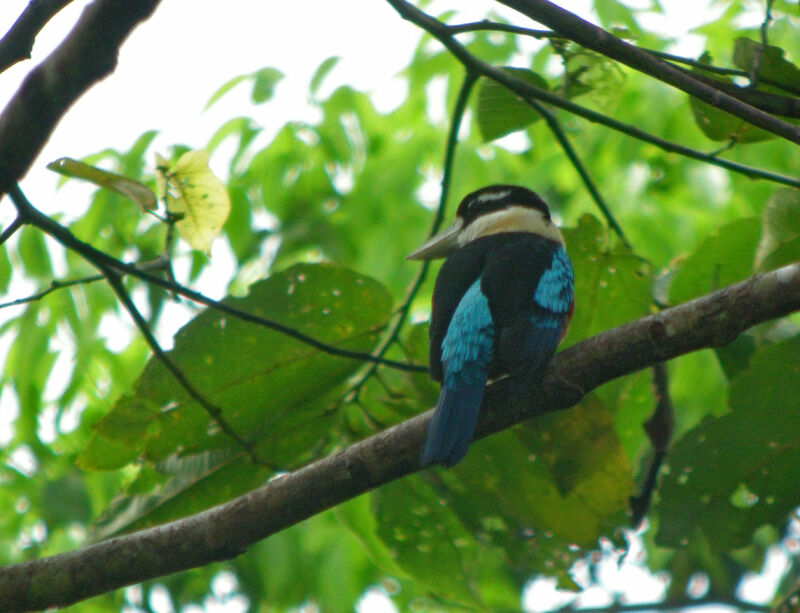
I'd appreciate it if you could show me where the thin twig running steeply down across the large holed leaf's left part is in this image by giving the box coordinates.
[101,266,267,466]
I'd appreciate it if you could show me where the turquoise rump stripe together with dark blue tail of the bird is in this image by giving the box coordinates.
[420,279,494,466]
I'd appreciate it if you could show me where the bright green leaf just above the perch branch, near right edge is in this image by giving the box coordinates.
[670,217,761,304]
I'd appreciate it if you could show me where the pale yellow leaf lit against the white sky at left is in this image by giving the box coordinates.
[156,149,231,253]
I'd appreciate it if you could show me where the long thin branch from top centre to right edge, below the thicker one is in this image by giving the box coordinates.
[388,0,800,188]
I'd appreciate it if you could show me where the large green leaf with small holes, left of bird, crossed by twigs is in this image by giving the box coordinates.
[80,264,391,468]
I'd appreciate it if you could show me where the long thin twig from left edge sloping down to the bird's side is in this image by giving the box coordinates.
[8,185,428,372]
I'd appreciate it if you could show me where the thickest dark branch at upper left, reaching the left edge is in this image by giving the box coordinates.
[0,0,159,195]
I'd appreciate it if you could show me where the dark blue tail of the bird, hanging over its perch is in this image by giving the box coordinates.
[419,379,486,467]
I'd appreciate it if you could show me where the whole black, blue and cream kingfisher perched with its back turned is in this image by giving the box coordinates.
[408,185,574,467]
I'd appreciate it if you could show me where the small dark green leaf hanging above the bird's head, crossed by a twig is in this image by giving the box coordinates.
[475,68,547,141]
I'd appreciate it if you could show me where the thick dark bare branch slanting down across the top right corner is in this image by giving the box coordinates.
[499,0,800,143]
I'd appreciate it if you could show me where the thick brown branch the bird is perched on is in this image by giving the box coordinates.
[0,263,800,611]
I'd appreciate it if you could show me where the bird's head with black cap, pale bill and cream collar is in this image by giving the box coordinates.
[408,185,564,260]
